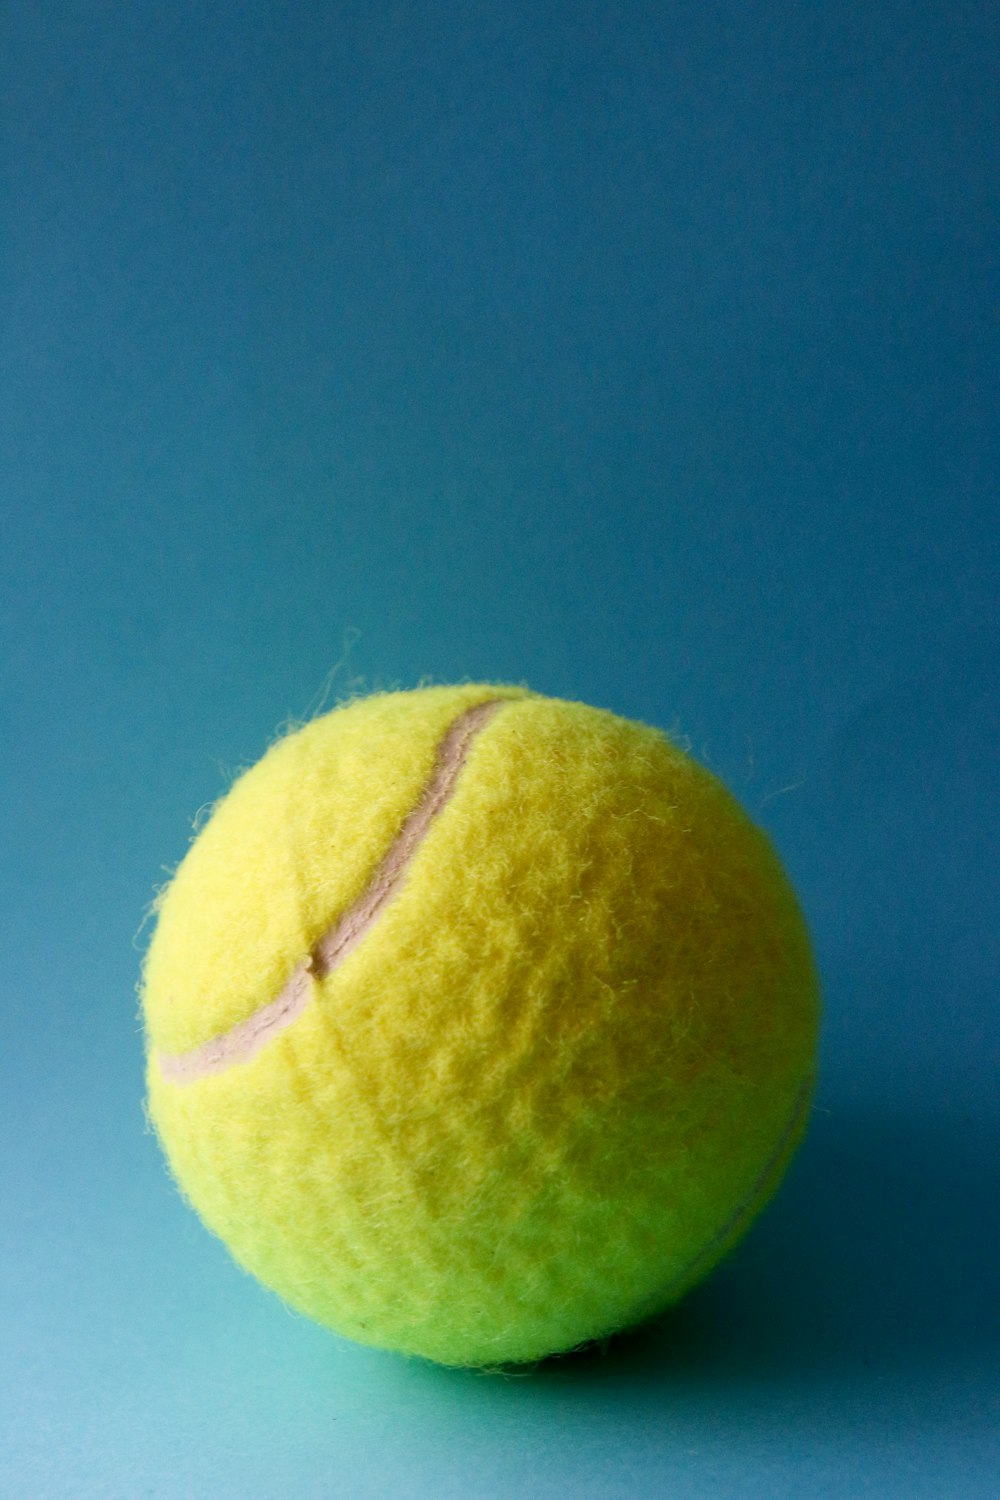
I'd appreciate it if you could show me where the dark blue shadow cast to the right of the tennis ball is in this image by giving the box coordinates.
[521,1110,1000,1383]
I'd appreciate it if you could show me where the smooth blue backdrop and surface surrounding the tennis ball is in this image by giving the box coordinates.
[0,0,1000,1500]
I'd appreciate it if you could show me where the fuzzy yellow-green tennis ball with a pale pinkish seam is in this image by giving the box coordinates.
[142,684,819,1367]
